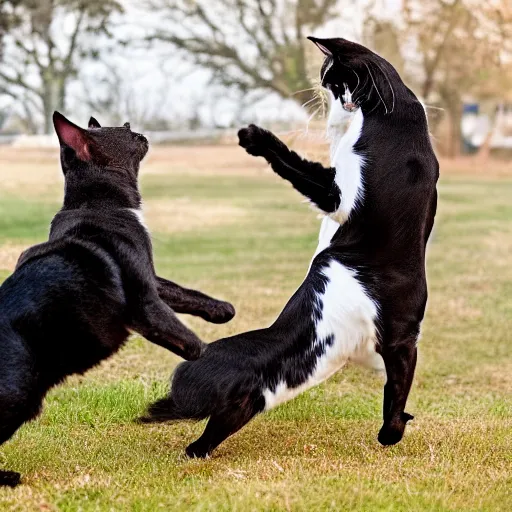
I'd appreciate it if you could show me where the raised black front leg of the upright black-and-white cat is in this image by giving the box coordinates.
[238,124,341,213]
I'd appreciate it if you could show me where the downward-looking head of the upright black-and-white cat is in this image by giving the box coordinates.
[308,37,417,123]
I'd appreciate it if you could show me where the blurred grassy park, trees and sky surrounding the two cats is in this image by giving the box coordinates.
[0,0,512,512]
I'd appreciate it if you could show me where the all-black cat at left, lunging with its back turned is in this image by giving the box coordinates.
[0,113,235,486]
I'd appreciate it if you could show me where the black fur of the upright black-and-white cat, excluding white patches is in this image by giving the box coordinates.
[143,39,439,456]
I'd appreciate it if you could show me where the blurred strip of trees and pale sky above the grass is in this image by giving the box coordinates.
[0,0,512,157]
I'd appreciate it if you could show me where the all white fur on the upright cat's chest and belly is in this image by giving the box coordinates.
[263,95,383,410]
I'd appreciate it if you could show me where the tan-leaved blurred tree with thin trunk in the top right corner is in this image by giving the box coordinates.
[401,0,512,156]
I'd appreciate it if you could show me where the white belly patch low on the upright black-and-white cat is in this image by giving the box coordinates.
[263,260,377,410]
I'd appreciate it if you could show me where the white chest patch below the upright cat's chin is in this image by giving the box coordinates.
[330,107,364,224]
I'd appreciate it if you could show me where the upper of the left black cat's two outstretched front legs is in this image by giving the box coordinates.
[156,277,235,324]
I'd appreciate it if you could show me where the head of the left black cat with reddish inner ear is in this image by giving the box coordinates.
[53,112,149,179]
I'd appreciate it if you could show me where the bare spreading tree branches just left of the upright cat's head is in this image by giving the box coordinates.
[146,0,342,112]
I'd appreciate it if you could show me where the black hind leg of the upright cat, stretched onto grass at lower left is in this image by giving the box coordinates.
[185,408,257,459]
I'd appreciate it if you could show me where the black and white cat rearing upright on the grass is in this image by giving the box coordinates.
[143,38,439,457]
